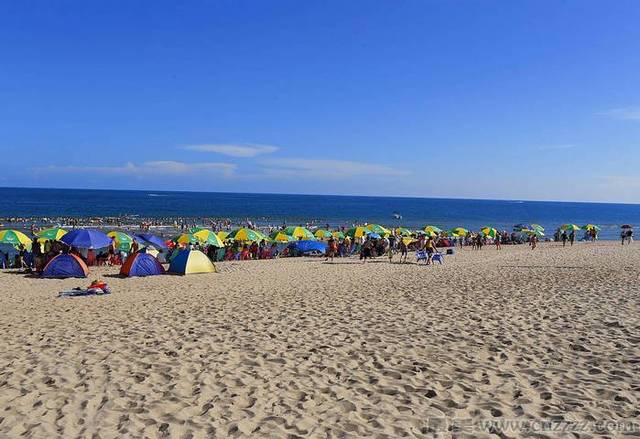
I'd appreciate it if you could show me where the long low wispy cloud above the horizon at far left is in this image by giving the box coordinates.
[32,160,237,177]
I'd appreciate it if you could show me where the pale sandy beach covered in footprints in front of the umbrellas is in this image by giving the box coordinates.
[0,242,640,438]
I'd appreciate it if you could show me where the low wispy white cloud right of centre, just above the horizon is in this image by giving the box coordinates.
[263,158,410,179]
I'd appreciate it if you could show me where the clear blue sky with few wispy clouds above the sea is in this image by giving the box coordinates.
[0,0,640,202]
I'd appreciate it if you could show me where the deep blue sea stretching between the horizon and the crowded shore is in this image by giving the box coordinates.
[0,188,640,239]
